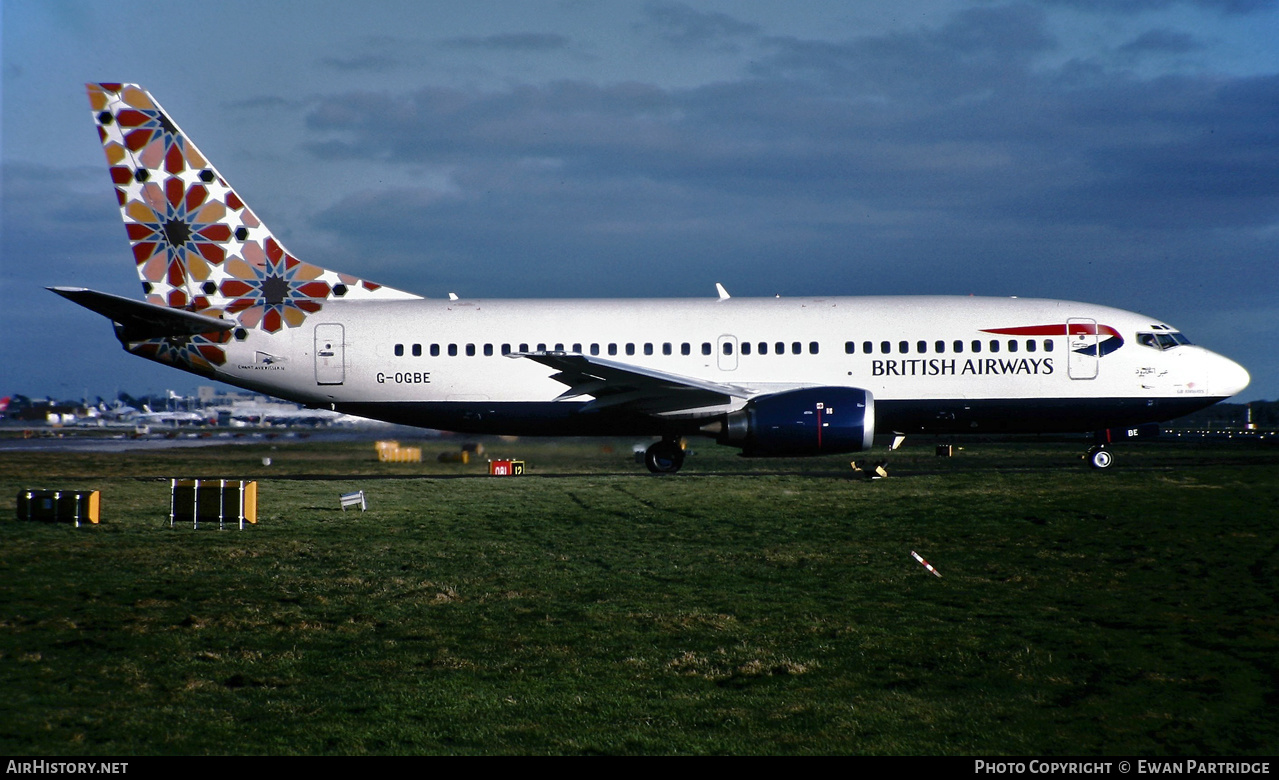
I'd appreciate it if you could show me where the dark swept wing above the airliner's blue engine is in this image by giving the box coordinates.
[510,352,757,414]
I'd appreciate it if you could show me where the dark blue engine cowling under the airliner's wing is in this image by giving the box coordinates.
[718,387,875,458]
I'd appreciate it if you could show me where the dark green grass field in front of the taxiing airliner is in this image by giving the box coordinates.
[0,441,1279,756]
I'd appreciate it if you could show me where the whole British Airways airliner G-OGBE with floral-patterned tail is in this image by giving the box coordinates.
[50,83,1250,473]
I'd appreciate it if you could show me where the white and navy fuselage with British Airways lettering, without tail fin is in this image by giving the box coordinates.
[207,297,1247,433]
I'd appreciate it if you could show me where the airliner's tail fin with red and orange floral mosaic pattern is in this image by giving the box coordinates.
[87,83,420,332]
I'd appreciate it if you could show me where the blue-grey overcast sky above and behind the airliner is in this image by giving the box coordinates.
[0,0,1279,400]
